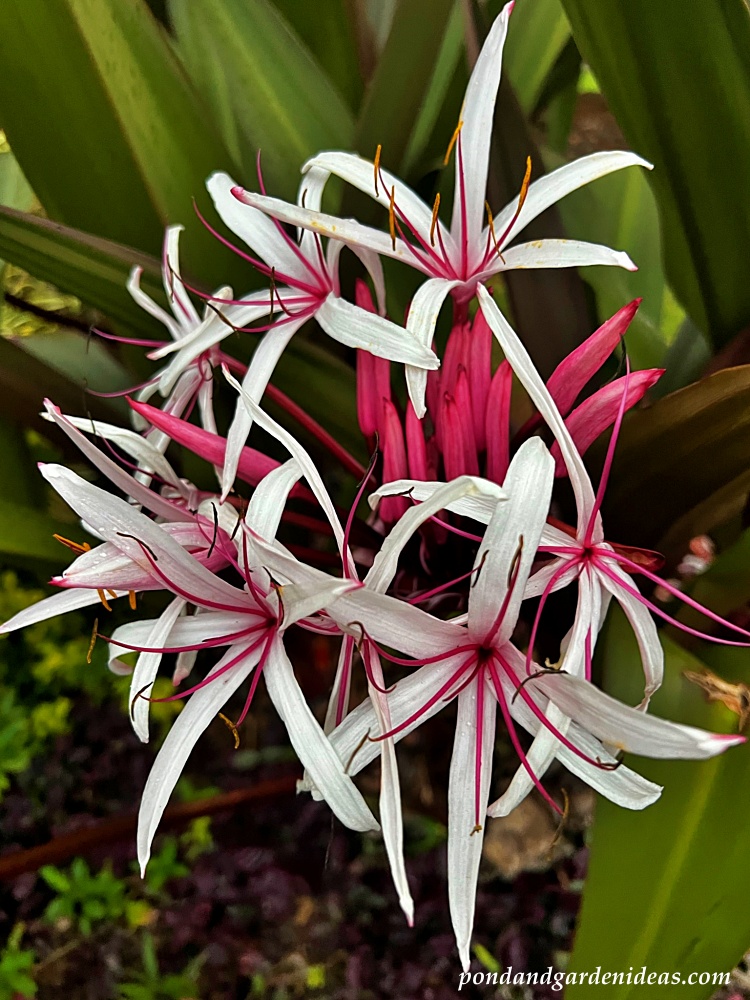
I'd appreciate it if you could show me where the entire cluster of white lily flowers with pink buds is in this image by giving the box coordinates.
[2,3,750,968]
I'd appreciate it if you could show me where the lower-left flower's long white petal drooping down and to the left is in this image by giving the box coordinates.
[137,647,260,876]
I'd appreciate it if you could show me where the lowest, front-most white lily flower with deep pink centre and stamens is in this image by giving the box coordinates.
[248,439,743,968]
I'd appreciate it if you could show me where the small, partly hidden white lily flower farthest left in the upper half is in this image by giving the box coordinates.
[125,226,273,452]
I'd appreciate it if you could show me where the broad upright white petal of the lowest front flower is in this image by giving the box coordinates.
[469,438,555,643]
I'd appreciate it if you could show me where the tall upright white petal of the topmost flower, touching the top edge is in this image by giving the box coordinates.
[451,2,513,254]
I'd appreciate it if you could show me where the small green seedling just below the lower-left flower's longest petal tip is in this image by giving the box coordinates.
[39,858,130,934]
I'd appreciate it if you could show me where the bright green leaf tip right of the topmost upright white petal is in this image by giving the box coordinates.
[503,0,570,114]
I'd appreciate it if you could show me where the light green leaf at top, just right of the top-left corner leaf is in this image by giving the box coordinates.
[170,0,354,197]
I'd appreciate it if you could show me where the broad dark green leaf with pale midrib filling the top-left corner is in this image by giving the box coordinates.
[0,0,241,283]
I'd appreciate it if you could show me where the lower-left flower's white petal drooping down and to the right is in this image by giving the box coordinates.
[264,638,380,831]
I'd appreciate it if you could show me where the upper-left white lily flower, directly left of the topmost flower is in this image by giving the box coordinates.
[191,170,440,497]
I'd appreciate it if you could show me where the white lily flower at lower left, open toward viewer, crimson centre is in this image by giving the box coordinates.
[27,462,378,870]
